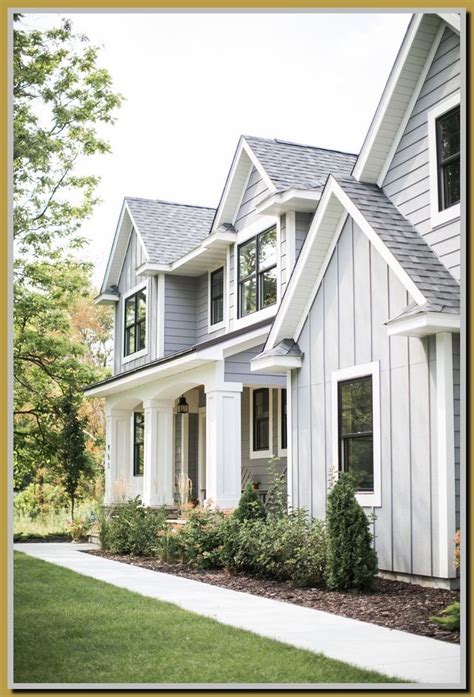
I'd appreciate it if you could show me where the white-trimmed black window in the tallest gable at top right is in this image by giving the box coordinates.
[427,92,461,228]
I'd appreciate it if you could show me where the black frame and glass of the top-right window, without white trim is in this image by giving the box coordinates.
[436,106,461,211]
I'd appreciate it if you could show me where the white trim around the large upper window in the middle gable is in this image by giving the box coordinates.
[234,216,281,329]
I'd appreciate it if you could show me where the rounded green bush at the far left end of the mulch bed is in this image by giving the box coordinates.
[103,496,166,556]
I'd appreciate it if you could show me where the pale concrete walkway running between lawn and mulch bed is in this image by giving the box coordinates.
[14,543,461,688]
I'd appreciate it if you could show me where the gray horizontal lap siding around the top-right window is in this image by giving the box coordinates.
[382,27,461,280]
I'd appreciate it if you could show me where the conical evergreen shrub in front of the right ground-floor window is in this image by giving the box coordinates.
[326,473,377,590]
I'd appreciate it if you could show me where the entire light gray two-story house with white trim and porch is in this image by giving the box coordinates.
[87,13,465,586]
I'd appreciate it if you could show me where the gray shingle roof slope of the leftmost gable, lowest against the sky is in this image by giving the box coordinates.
[125,196,215,264]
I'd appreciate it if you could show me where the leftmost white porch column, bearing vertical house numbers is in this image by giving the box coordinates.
[104,406,131,505]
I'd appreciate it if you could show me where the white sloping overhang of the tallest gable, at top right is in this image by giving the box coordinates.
[353,12,461,186]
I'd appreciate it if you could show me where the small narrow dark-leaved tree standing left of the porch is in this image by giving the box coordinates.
[59,392,93,520]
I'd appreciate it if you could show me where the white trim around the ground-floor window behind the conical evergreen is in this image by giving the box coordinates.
[331,361,382,508]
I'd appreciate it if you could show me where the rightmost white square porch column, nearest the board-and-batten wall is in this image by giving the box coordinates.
[206,383,242,508]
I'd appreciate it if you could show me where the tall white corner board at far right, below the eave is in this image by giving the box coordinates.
[435,332,456,578]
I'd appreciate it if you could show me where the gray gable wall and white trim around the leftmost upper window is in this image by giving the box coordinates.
[114,230,158,375]
